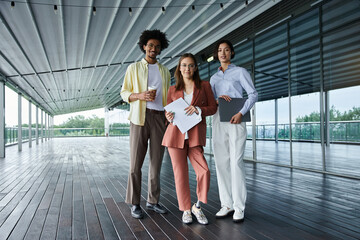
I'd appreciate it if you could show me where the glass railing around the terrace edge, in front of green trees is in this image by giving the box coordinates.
[5,121,360,144]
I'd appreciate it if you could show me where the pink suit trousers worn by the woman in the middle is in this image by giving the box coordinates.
[168,140,210,211]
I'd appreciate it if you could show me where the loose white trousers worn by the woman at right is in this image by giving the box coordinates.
[212,111,247,211]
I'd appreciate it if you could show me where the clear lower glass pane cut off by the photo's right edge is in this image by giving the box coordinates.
[325,86,360,176]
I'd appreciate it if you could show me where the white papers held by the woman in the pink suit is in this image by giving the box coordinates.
[164,98,201,133]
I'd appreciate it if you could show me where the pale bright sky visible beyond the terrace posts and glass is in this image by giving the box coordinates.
[5,85,360,126]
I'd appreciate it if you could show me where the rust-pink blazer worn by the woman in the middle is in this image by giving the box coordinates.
[162,81,217,148]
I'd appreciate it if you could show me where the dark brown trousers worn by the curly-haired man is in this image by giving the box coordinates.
[126,109,166,205]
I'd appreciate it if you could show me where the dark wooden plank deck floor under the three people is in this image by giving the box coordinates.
[0,138,360,240]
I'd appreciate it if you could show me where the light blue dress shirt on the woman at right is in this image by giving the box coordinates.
[210,64,258,115]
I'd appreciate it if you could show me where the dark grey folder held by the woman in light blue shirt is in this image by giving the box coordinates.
[219,98,251,122]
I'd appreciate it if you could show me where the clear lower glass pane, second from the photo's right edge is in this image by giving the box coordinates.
[291,92,322,170]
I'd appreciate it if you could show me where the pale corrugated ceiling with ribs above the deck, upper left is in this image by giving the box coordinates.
[0,0,280,115]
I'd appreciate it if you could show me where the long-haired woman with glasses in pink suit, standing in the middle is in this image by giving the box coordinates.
[162,53,217,224]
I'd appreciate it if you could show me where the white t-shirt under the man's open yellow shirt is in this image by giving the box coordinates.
[146,63,164,111]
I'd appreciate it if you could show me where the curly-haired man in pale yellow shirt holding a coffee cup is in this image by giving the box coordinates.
[121,29,170,218]
